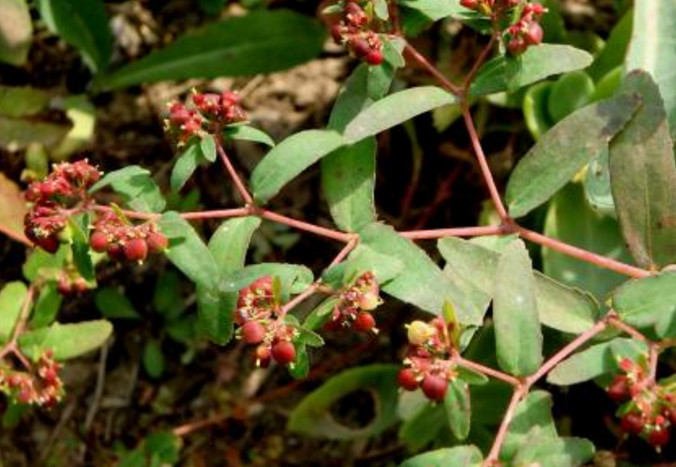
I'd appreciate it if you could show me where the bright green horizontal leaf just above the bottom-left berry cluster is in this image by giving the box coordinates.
[19,320,113,360]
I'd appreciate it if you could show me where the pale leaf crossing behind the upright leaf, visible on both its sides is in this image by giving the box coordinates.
[438,237,599,334]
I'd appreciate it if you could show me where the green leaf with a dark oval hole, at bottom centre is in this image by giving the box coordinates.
[287,365,398,440]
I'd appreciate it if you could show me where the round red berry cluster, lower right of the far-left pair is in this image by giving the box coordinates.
[89,211,169,262]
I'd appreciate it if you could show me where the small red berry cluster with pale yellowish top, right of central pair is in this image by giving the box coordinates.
[325,272,383,333]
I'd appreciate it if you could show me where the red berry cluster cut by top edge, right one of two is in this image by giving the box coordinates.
[460,0,547,56]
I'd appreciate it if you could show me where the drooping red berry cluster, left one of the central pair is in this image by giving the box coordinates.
[235,276,298,368]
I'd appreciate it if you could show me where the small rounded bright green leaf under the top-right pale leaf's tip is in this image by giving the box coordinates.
[547,71,595,122]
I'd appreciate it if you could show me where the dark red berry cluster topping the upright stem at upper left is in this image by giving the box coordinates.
[166,91,248,143]
